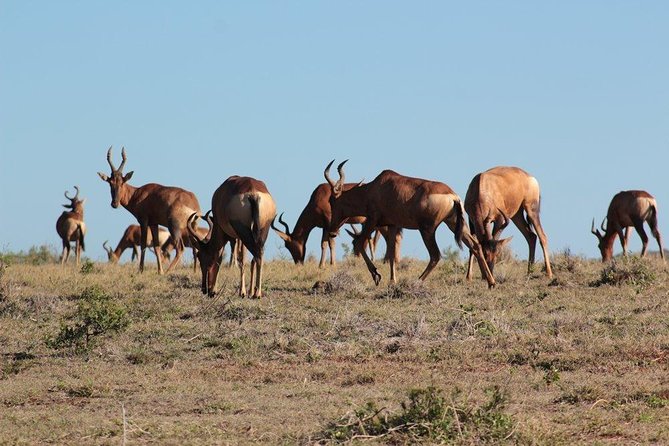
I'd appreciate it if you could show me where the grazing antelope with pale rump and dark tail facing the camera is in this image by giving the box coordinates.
[188,175,276,298]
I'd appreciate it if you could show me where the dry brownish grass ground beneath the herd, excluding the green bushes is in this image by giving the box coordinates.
[0,253,669,444]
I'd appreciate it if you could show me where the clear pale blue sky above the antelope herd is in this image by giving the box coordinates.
[0,0,669,260]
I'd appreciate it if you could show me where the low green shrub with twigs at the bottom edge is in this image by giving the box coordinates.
[321,386,515,444]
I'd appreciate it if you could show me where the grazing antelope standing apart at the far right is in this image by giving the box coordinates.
[590,190,664,262]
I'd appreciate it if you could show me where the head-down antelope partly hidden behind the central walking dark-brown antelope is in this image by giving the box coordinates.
[271,183,394,268]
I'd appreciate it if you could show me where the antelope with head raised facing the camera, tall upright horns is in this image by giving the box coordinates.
[98,147,201,274]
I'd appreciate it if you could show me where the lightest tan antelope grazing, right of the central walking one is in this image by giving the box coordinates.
[465,167,553,280]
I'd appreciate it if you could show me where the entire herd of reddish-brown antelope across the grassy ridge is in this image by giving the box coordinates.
[56,147,664,298]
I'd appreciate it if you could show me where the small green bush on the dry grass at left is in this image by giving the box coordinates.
[46,286,130,353]
